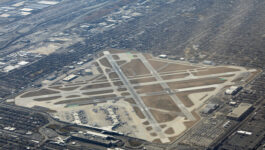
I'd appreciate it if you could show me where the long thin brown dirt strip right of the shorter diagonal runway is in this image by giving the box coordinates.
[168,77,226,89]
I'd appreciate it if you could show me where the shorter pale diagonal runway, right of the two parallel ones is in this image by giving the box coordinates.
[137,54,195,120]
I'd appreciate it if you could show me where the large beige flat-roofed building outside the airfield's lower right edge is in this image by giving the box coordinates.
[227,103,252,121]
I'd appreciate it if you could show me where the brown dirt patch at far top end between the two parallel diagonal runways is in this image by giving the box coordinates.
[121,59,150,76]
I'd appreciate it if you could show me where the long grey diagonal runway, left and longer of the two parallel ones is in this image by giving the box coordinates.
[105,54,165,138]
